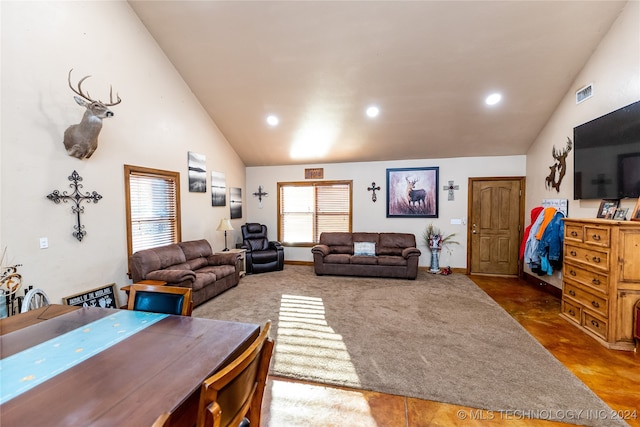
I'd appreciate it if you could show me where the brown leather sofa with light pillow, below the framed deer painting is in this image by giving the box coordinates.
[311,233,421,280]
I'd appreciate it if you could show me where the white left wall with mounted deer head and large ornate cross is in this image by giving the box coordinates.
[0,1,245,303]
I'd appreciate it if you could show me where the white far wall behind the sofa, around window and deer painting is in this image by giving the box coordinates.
[245,156,526,268]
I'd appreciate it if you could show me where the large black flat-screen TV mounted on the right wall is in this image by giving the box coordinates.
[573,101,640,200]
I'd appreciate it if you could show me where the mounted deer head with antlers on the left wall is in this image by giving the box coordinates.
[64,68,122,159]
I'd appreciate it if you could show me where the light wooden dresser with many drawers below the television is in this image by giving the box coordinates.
[561,218,640,350]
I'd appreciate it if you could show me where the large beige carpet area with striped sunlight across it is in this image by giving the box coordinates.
[193,265,626,426]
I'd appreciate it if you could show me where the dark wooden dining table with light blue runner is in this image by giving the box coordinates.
[0,304,260,427]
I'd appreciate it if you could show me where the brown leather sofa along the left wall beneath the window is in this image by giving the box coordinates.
[129,239,241,307]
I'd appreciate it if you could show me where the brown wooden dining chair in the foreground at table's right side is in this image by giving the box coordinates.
[196,321,273,427]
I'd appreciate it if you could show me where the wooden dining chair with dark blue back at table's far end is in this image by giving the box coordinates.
[127,284,193,316]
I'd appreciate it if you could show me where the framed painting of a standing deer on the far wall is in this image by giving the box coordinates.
[387,167,439,218]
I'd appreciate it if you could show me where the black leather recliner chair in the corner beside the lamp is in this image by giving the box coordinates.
[241,222,284,274]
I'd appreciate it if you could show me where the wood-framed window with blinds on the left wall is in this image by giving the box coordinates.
[124,165,181,255]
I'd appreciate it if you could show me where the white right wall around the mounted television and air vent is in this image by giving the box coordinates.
[526,1,640,287]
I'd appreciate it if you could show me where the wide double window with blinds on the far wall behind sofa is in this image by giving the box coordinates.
[278,181,352,246]
